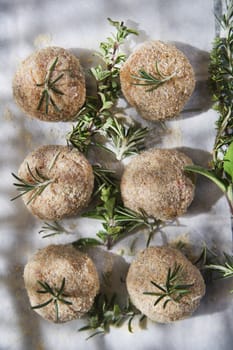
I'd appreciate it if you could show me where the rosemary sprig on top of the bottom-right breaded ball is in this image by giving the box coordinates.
[143,263,193,309]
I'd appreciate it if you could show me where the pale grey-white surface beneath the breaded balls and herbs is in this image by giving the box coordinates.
[0,0,233,350]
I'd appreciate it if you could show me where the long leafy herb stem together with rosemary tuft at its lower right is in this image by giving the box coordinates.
[67,18,147,160]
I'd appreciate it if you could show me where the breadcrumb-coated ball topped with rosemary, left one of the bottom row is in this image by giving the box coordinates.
[24,244,99,323]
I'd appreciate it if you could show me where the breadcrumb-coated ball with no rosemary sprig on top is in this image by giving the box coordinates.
[121,148,195,220]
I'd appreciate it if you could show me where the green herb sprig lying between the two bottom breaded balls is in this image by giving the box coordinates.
[79,294,144,339]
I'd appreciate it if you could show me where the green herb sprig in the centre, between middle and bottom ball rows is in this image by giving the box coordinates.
[83,186,162,249]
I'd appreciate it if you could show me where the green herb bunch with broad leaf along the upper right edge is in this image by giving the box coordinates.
[186,0,233,216]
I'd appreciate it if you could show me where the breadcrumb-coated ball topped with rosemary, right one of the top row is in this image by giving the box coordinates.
[120,41,195,120]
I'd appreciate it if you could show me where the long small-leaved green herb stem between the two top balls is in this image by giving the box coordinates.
[67,18,141,157]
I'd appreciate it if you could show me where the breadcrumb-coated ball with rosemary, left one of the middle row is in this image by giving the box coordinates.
[18,145,94,220]
